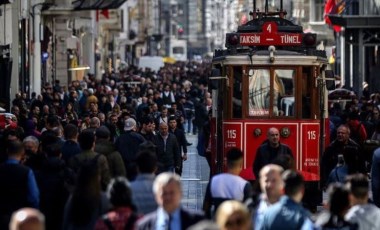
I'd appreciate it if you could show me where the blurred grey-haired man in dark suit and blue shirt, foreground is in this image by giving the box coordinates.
[137,172,204,230]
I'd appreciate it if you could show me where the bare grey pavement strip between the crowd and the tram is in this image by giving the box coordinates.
[181,135,210,210]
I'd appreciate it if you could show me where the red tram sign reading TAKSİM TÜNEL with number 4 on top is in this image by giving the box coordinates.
[239,22,303,46]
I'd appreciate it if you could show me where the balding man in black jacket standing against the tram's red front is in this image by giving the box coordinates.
[253,127,293,178]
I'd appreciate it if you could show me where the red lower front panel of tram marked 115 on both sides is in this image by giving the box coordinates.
[223,120,320,182]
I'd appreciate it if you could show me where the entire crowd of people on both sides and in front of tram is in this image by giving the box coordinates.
[0,57,380,230]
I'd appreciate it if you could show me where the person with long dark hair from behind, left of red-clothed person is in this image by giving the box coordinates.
[63,161,110,230]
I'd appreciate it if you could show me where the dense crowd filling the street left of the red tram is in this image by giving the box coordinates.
[0,62,211,229]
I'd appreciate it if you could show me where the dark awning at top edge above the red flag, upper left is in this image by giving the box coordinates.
[72,0,127,10]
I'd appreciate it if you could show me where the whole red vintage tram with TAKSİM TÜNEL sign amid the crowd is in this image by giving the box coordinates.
[210,0,335,205]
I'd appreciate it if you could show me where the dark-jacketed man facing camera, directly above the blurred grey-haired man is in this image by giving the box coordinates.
[154,122,182,173]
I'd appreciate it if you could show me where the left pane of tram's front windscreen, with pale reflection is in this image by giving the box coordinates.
[248,69,270,116]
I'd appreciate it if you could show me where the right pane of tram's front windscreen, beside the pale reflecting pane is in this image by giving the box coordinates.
[273,69,296,116]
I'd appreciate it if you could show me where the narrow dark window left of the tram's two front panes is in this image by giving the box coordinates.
[232,66,243,118]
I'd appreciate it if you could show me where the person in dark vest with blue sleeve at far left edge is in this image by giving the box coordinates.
[0,141,40,229]
